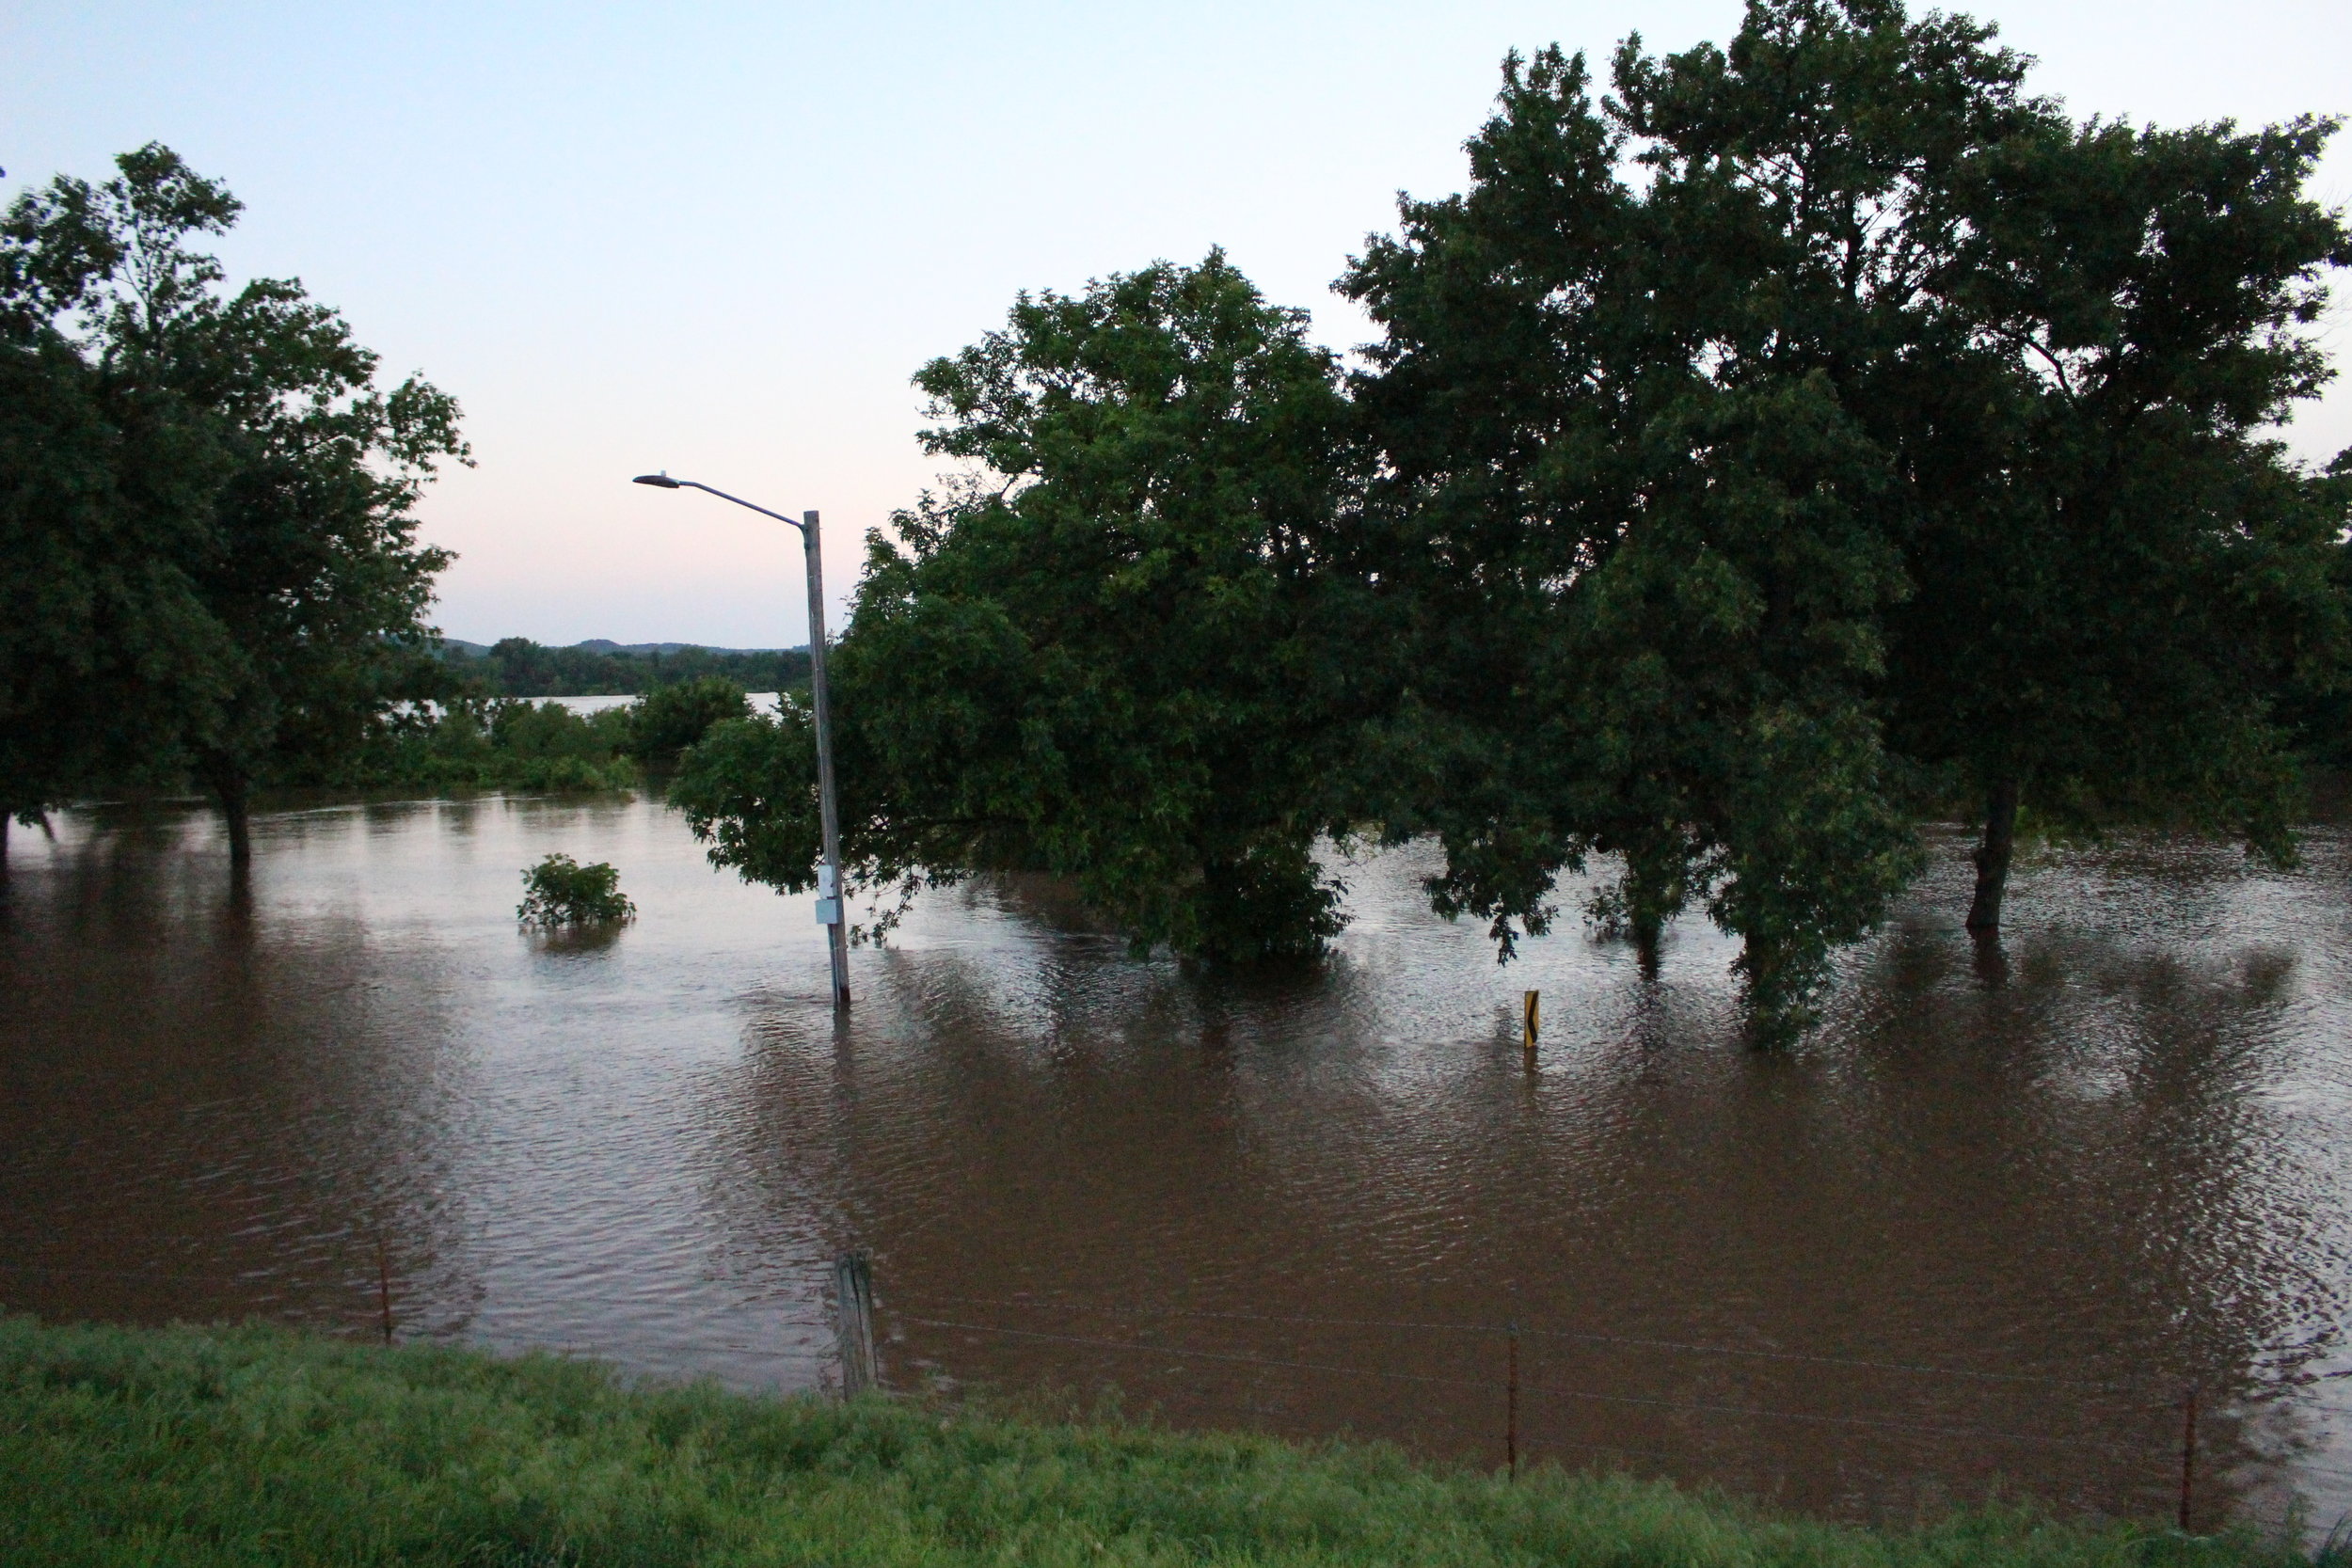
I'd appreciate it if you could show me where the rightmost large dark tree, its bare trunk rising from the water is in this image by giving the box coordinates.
[1891,119,2352,931]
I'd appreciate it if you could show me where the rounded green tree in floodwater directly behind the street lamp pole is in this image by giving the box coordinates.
[673,251,1383,959]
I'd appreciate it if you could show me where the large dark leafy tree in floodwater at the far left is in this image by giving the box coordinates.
[0,146,466,863]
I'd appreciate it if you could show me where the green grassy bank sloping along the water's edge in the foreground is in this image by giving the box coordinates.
[0,1319,2303,1568]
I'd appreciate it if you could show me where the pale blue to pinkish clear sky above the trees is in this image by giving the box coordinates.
[0,0,2352,646]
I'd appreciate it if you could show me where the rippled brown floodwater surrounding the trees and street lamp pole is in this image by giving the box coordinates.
[0,797,2352,1528]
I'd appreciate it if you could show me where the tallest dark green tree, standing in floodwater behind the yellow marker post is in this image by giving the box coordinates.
[1343,11,1994,1027]
